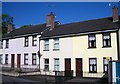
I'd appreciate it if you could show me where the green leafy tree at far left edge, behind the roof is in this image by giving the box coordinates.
[0,14,15,34]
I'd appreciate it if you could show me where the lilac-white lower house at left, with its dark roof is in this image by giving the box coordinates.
[0,25,47,71]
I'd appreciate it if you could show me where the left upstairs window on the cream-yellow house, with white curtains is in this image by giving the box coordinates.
[88,34,96,48]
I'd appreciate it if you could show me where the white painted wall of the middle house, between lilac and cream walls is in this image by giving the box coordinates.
[40,37,73,75]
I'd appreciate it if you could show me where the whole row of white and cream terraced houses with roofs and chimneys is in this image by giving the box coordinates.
[0,7,120,77]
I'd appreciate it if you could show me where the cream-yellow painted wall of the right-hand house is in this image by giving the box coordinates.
[73,33,118,77]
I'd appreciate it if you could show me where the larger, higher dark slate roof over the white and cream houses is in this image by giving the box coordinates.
[41,17,120,39]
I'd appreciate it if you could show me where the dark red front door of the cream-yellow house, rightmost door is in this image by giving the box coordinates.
[76,58,82,77]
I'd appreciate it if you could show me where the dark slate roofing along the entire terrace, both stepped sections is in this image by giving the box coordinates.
[3,17,119,39]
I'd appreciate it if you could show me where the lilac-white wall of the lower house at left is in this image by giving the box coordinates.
[0,35,39,69]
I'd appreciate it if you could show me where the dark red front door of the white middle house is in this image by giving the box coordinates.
[65,59,71,76]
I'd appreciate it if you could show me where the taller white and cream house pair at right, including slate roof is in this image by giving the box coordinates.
[40,7,120,77]
